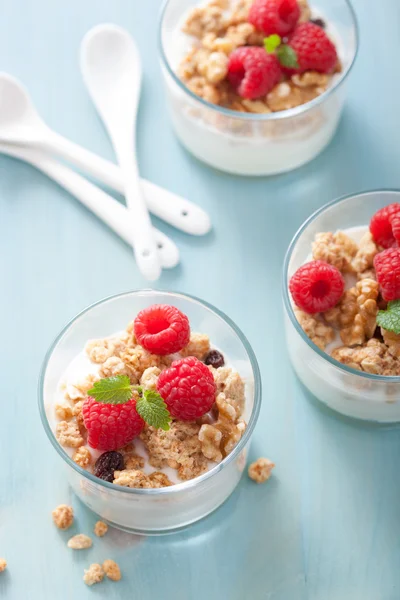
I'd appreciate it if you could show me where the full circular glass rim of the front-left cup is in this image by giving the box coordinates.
[38,289,262,495]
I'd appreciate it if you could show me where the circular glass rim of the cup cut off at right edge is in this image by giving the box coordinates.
[282,188,400,383]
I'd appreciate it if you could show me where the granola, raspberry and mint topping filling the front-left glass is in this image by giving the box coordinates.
[54,304,246,488]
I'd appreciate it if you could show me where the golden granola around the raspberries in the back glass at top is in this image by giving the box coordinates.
[178,0,341,114]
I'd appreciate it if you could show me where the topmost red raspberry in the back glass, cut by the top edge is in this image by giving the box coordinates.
[248,0,300,36]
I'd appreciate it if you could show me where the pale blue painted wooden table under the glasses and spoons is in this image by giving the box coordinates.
[0,0,400,600]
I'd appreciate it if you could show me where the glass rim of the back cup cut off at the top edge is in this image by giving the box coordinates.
[158,0,360,121]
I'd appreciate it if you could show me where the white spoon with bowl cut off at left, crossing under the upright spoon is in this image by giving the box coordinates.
[0,73,211,235]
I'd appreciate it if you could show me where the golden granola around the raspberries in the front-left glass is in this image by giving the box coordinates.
[55,324,246,488]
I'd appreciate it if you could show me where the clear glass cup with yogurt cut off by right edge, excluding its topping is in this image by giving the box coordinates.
[283,190,400,423]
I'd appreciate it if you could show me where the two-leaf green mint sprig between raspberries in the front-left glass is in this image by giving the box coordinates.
[88,375,171,431]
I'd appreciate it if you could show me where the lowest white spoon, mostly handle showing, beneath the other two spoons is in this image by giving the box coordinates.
[0,144,179,269]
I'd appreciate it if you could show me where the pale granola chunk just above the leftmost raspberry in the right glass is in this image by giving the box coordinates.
[312,231,358,273]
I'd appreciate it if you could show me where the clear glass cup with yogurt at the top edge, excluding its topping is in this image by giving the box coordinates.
[159,0,358,175]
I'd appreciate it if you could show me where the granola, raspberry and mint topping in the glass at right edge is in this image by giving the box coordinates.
[289,203,400,378]
